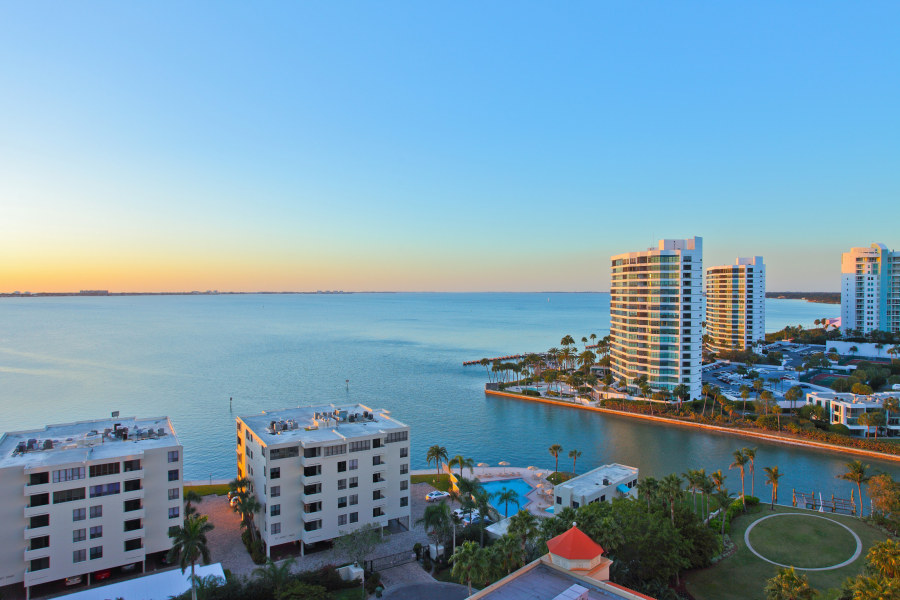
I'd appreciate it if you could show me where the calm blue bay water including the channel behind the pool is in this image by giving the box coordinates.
[0,294,900,498]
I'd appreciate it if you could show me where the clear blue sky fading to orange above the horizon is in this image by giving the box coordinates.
[0,0,900,292]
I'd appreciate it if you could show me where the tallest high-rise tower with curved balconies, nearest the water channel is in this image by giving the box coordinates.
[610,237,703,398]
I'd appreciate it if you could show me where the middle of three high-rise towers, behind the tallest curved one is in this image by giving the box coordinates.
[705,256,766,352]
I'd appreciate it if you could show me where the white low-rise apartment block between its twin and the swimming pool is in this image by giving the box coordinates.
[237,404,410,553]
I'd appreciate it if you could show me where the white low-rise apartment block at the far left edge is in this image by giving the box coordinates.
[0,417,183,595]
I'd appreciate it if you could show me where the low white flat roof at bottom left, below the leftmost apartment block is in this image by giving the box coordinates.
[57,563,225,600]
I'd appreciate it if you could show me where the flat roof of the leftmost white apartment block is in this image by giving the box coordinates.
[0,417,180,469]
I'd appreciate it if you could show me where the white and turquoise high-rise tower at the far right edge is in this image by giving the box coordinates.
[841,244,900,334]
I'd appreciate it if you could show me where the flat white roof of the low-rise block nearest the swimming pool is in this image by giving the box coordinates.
[238,404,407,446]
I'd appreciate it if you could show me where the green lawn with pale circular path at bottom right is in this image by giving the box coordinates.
[685,505,887,600]
